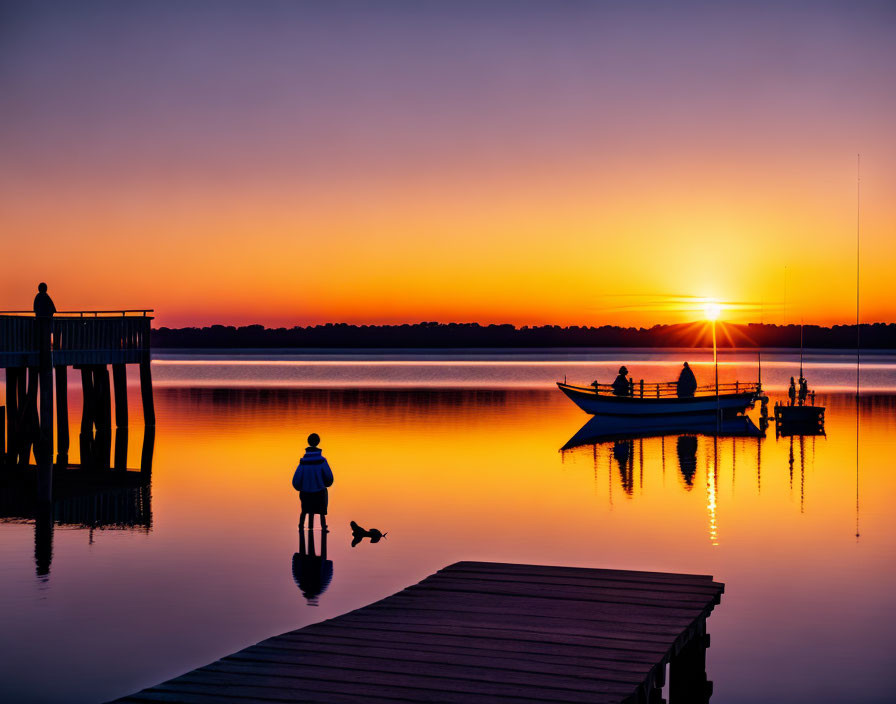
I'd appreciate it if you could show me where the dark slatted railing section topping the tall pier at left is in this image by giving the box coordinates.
[0,309,152,367]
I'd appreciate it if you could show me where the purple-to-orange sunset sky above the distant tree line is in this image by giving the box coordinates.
[0,1,896,325]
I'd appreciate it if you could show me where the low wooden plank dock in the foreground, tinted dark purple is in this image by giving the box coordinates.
[118,562,724,704]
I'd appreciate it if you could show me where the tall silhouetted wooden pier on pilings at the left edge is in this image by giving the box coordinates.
[0,309,155,501]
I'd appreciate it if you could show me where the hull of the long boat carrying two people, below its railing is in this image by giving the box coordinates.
[557,383,756,417]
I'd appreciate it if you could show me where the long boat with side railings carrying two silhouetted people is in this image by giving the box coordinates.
[557,381,761,418]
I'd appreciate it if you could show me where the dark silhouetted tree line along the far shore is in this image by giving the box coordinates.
[152,323,896,349]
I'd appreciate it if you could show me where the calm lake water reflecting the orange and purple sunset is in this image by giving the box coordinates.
[0,351,896,704]
